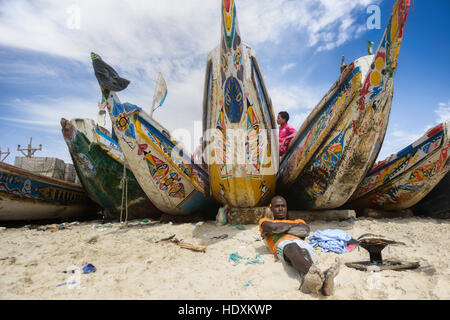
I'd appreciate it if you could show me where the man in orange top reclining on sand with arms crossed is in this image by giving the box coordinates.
[259,196,340,296]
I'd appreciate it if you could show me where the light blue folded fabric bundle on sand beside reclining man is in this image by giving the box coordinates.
[308,229,352,253]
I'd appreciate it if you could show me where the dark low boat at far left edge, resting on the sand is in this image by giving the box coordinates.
[0,162,98,221]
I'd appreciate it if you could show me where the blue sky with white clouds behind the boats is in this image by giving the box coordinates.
[0,0,450,163]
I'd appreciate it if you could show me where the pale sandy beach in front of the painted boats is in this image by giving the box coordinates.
[0,217,450,300]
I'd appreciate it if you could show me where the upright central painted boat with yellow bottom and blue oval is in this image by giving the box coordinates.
[203,0,279,207]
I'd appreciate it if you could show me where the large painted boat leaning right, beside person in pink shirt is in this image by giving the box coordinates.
[277,0,409,209]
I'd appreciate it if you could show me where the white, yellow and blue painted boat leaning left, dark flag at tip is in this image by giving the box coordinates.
[91,53,215,215]
